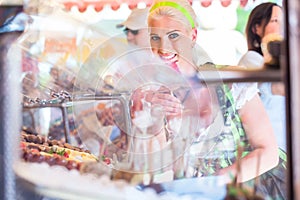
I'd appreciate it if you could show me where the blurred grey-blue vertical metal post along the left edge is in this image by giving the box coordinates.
[0,28,21,199]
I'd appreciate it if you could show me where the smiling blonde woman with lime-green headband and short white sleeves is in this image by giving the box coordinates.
[148,0,286,199]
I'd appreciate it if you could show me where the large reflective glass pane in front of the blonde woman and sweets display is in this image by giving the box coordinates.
[10,1,286,199]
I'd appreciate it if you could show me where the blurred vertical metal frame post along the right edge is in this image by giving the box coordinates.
[284,0,300,199]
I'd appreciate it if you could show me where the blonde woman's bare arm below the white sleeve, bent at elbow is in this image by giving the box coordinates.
[220,95,279,182]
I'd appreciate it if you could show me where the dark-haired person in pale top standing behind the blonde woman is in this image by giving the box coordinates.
[238,2,286,150]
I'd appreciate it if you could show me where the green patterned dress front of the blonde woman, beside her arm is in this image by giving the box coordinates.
[198,84,252,175]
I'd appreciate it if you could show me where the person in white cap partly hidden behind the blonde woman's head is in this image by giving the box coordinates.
[117,8,150,47]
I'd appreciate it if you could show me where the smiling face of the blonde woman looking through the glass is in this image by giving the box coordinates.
[149,16,196,75]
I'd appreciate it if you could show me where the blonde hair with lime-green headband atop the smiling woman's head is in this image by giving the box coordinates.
[148,0,198,30]
